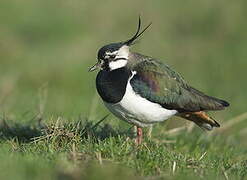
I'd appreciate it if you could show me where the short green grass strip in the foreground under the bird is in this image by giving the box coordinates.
[0,114,247,179]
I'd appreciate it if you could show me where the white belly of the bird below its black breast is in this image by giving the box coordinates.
[104,82,177,127]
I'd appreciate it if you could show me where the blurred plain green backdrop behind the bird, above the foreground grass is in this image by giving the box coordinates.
[0,0,247,179]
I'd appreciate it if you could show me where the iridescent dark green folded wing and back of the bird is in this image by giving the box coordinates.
[130,58,229,112]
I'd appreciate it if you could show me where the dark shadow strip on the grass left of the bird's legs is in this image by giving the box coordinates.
[0,116,134,143]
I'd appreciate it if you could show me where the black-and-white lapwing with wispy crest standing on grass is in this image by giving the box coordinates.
[89,16,229,145]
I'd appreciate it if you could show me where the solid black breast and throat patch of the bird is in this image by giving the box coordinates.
[96,67,132,103]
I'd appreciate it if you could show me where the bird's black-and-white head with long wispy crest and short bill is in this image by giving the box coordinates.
[89,17,151,71]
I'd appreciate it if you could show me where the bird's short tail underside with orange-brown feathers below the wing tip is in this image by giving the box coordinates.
[179,111,220,131]
